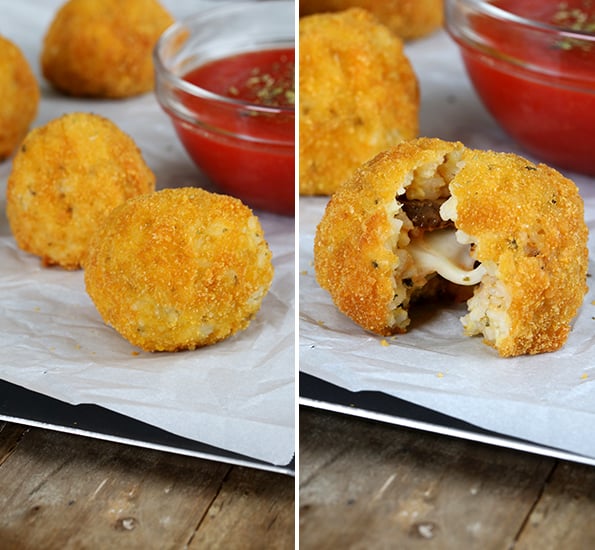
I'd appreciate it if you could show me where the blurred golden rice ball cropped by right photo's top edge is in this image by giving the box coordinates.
[300,0,444,40]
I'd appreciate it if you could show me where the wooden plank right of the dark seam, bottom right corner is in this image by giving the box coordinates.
[515,462,595,550]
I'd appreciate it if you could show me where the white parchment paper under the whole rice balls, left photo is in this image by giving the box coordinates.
[0,0,295,465]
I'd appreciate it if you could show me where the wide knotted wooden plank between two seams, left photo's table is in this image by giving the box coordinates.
[0,429,230,549]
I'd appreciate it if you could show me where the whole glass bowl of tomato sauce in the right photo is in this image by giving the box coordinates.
[445,0,595,176]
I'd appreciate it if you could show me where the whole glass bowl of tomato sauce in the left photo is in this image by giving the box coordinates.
[154,0,295,215]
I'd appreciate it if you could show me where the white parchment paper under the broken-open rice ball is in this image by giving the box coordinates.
[299,32,595,457]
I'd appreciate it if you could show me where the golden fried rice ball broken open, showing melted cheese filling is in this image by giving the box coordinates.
[314,138,588,357]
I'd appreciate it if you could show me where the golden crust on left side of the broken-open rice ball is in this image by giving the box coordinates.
[314,138,453,335]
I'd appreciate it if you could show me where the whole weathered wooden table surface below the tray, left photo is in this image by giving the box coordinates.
[0,423,295,550]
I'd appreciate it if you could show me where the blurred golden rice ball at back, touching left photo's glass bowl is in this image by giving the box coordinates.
[41,0,174,98]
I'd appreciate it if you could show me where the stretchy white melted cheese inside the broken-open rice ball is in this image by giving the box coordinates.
[407,229,486,286]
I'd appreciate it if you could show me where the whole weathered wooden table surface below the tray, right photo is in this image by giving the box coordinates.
[299,407,595,550]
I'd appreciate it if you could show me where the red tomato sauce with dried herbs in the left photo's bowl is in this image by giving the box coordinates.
[176,48,295,215]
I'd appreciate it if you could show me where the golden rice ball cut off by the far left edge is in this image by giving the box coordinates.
[0,36,39,161]
